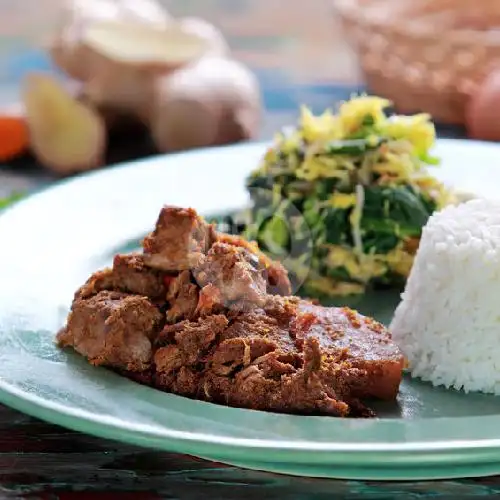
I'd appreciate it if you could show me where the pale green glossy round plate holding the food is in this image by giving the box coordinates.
[0,141,500,480]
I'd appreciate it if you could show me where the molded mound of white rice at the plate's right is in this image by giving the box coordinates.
[390,200,500,394]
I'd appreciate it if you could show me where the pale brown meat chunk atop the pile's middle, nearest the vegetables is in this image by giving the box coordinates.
[193,242,266,307]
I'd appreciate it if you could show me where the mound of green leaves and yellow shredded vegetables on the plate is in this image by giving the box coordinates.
[245,96,454,297]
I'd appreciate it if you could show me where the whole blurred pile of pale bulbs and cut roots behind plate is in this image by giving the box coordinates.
[43,0,261,172]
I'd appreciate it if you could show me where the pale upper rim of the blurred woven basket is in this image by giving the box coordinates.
[332,0,500,48]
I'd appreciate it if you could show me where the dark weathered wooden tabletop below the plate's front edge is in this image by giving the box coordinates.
[0,407,500,500]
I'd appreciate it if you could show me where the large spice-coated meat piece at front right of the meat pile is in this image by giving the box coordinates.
[155,297,404,416]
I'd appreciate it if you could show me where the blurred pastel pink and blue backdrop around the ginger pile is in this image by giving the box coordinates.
[0,0,363,133]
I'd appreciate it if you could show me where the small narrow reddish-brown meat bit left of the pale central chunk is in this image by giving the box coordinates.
[167,271,198,323]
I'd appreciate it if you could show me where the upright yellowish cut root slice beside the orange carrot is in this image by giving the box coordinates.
[23,74,106,174]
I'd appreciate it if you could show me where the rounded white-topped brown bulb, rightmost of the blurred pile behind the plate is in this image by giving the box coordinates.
[151,56,261,151]
